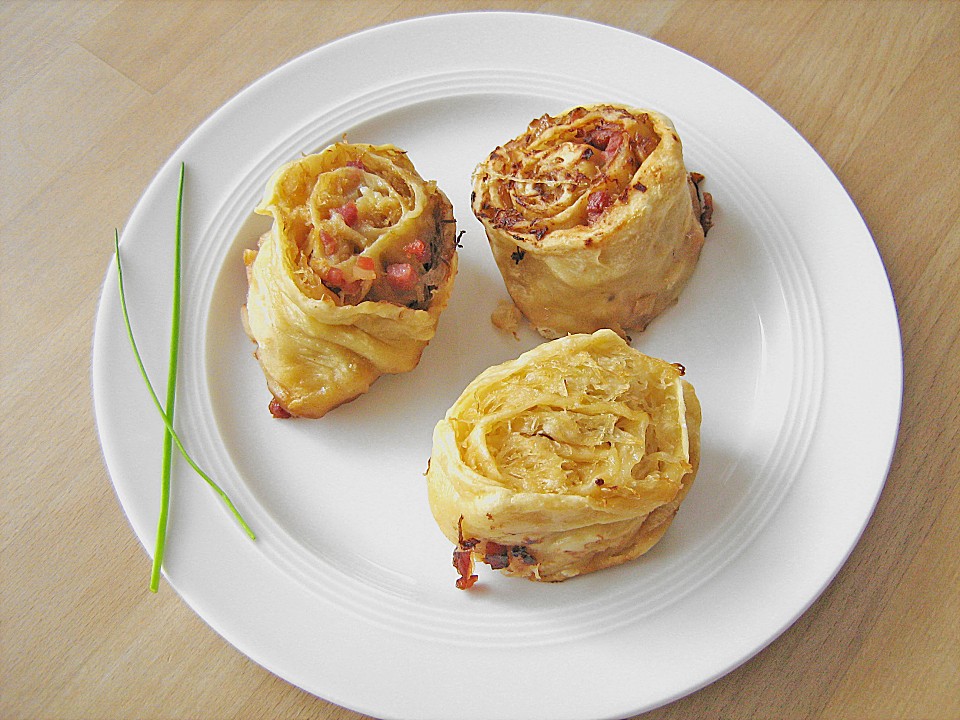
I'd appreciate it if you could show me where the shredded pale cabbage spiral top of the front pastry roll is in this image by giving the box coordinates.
[455,352,690,495]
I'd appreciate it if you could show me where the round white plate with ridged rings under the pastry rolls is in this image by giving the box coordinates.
[93,13,901,720]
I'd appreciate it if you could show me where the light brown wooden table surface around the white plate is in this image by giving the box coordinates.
[0,0,960,720]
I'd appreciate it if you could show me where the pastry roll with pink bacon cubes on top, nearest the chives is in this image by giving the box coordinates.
[242,143,457,418]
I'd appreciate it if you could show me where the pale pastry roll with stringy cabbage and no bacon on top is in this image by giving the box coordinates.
[426,329,700,588]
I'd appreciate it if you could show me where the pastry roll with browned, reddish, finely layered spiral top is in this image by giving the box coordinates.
[472,105,712,338]
